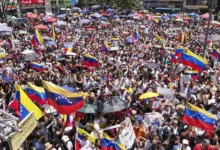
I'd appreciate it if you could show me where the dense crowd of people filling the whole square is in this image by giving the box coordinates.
[0,6,220,150]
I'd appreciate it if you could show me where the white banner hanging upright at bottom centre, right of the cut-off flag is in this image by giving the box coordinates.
[119,118,136,149]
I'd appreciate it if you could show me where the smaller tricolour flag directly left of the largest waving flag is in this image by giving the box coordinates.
[27,83,47,105]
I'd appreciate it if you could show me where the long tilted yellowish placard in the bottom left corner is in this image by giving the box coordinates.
[9,112,37,150]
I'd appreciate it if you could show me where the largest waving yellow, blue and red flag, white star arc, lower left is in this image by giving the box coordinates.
[42,81,84,114]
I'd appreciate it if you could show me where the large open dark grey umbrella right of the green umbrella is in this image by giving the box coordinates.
[97,96,128,113]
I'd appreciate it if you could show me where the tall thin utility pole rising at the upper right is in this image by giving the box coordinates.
[203,0,214,57]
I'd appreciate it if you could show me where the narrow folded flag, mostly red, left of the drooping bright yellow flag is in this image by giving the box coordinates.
[8,84,20,116]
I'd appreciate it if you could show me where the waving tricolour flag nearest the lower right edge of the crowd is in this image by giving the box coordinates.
[183,103,218,134]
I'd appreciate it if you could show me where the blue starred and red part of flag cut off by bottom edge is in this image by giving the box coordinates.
[101,138,121,150]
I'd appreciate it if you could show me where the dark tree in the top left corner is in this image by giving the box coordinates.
[0,0,15,23]
